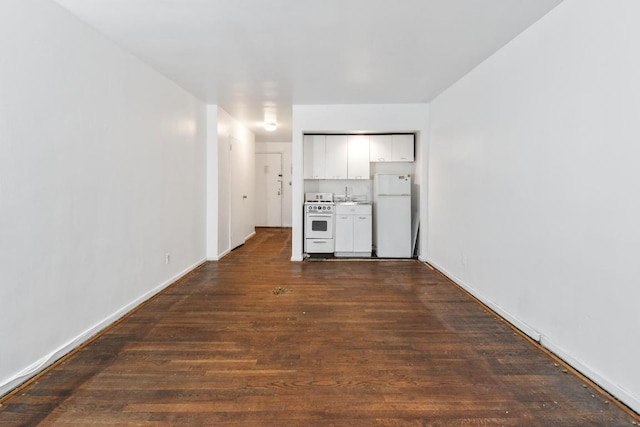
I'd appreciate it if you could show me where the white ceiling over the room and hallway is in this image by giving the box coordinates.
[56,0,561,142]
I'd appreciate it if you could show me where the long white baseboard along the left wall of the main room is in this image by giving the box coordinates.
[0,259,205,397]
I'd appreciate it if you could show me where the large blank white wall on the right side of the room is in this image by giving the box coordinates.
[428,0,640,411]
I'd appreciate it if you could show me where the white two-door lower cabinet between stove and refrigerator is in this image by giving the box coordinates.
[335,204,372,257]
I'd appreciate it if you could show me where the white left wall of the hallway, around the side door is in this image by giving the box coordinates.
[207,105,255,261]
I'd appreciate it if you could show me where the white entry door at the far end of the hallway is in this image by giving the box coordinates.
[255,153,282,227]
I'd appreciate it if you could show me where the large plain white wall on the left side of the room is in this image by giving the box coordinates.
[0,0,205,394]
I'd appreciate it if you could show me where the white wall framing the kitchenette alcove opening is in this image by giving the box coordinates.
[291,104,429,261]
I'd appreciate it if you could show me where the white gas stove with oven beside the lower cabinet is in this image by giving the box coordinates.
[304,193,336,254]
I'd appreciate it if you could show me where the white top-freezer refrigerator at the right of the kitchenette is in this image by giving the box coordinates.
[373,174,413,258]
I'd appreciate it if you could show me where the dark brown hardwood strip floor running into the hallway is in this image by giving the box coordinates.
[0,229,638,426]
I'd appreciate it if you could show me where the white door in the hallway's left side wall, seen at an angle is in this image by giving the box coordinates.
[229,136,248,249]
